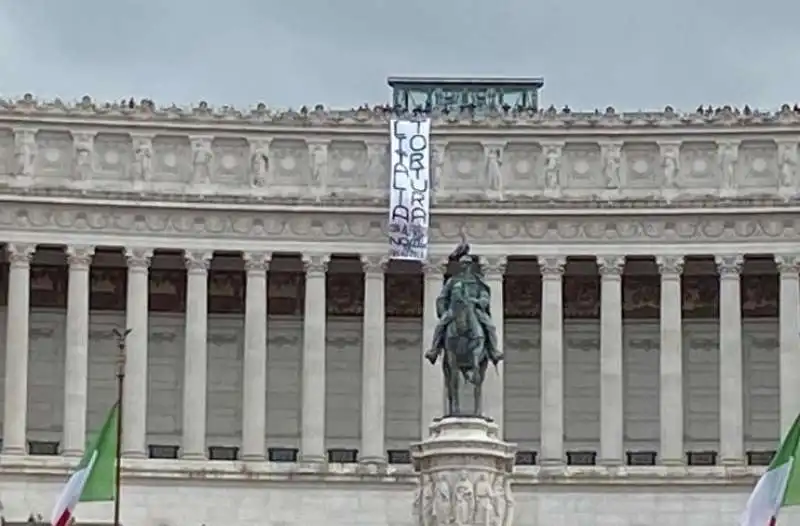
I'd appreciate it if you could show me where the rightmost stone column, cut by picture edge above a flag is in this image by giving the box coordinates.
[775,255,800,437]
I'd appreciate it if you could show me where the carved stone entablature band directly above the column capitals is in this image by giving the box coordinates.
[0,201,800,258]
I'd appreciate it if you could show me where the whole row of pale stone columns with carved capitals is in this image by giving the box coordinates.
[3,244,800,465]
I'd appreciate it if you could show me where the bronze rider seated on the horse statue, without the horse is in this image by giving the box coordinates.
[425,243,503,371]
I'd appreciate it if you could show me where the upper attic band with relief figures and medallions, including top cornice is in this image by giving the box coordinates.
[0,96,800,209]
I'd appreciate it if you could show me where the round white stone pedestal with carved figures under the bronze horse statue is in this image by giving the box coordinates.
[411,416,516,526]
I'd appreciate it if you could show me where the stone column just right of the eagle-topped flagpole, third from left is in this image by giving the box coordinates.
[122,248,153,458]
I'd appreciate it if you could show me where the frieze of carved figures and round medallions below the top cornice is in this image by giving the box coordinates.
[0,127,797,206]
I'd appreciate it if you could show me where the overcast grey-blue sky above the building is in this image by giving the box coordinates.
[0,0,800,110]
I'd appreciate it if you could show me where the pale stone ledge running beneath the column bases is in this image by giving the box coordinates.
[0,457,764,491]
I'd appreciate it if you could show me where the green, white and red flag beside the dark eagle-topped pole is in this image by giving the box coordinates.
[50,404,119,526]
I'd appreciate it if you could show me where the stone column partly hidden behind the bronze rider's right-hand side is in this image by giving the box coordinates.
[481,256,507,437]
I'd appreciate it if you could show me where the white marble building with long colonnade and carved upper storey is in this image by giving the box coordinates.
[0,98,800,526]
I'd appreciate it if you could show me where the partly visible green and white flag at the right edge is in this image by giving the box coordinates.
[740,416,800,526]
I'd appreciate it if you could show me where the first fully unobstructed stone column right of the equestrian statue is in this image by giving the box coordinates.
[539,256,566,466]
